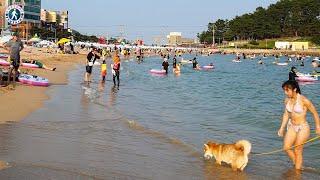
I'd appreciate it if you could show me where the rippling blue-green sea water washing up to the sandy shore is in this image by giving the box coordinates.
[0,55,320,179]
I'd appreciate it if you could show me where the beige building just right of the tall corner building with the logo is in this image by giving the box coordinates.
[41,9,69,29]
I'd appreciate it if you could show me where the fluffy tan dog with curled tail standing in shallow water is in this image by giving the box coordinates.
[204,140,251,171]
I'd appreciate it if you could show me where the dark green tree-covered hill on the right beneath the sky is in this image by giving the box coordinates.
[198,0,320,44]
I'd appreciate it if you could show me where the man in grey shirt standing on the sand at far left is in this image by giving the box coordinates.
[4,32,24,89]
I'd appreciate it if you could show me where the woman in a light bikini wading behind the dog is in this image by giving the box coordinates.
[278,80,320,170]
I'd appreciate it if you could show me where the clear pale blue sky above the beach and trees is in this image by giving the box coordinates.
[42,0,277,44]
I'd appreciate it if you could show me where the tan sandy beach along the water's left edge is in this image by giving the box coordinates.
[0,47,86,123]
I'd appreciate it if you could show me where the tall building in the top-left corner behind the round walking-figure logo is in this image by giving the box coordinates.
[0,0,41,39]
